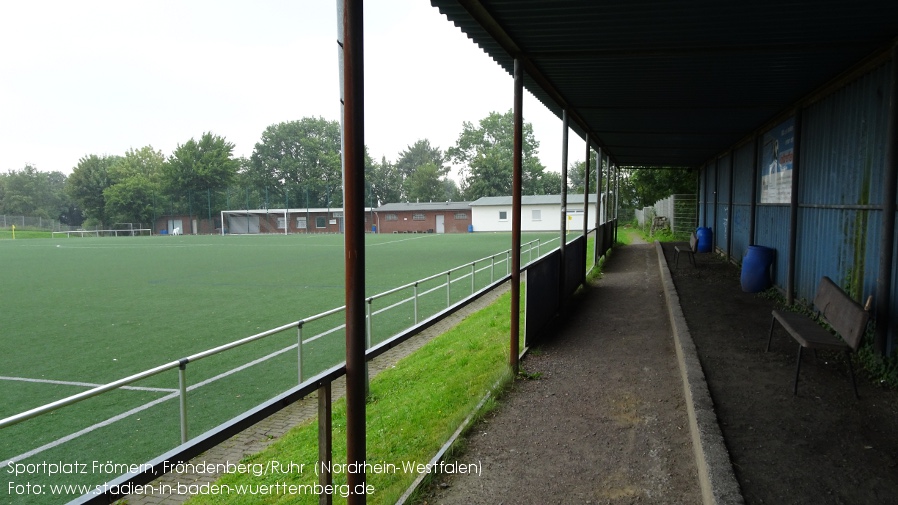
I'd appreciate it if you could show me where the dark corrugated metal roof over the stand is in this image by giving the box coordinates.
[431,0,898,167]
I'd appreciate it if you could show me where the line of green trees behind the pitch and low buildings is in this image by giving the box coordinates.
[0,110,682,225]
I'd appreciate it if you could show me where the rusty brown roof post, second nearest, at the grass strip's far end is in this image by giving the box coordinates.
[509,59,524,375]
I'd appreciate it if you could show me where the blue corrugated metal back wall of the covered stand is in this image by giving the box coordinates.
[700,60,898,348]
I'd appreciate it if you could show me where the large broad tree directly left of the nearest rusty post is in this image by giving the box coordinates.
[244,117,342,207]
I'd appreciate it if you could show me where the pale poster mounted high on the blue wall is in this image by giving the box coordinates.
[761,118,795,203]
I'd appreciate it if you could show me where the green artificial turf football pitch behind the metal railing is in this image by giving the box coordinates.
[0,232,557,502]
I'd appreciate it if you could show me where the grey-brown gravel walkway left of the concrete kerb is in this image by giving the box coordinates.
[419,238,701,505]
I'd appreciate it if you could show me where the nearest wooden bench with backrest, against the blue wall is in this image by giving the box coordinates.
[767,277,872,398]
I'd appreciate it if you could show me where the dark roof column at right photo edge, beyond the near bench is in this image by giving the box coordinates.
[873,44,898,354]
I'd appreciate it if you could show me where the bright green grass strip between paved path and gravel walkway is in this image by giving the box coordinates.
[188,293,511,505]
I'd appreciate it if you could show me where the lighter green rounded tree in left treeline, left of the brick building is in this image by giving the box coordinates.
[103,146,165,225]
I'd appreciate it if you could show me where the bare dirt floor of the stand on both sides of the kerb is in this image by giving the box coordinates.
[420,237,898,505]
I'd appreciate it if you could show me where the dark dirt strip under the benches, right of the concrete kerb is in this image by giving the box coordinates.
[664,244,898,504]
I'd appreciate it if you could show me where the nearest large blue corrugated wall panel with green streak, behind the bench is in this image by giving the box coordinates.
[795,64,890,301]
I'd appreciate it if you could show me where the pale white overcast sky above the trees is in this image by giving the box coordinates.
[0,0,584,181]
